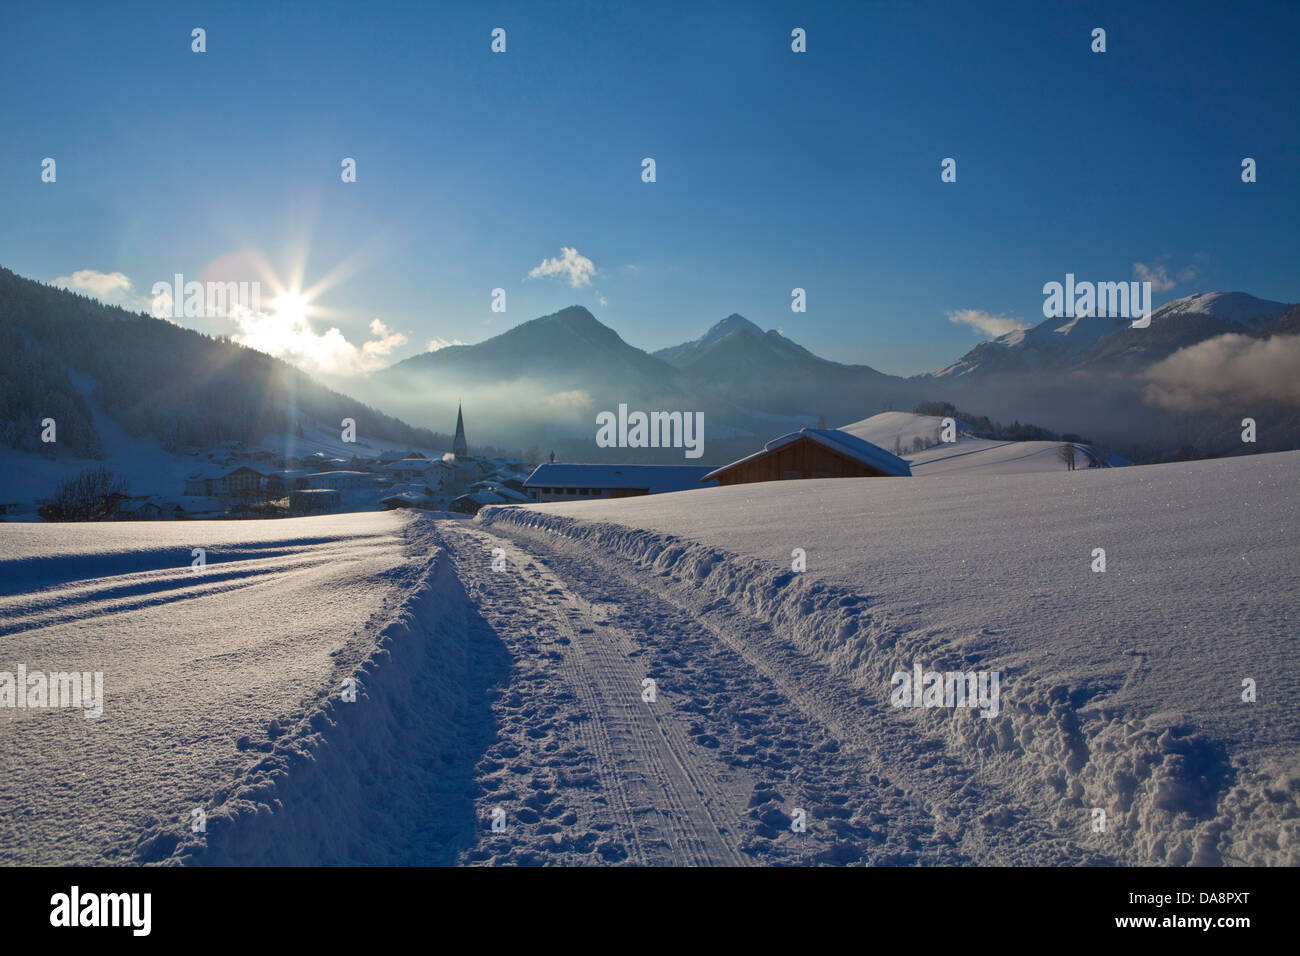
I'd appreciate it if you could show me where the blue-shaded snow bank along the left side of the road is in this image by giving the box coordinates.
[134,522,476,865]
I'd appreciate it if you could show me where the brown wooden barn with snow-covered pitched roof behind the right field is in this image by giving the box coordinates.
[702,428,911,485]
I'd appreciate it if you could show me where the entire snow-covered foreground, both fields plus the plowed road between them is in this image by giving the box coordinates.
[0,453,1300,865]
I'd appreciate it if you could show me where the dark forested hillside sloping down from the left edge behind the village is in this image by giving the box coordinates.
[0,261,450,457]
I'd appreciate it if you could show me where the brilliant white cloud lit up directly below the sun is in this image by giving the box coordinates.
[231,311,407,377]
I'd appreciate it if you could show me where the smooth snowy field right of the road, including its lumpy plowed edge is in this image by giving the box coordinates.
[481,453,1300,864]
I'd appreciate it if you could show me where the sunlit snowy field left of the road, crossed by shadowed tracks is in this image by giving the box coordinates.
[0,514,420,864]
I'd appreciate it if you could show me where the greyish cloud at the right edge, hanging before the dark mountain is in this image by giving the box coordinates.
[1143,333,1300,410]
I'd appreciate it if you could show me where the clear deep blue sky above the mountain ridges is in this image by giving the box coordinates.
[0,0,1300,375]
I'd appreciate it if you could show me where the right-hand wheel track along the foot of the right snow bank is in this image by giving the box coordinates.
[480,522,1096,865]
